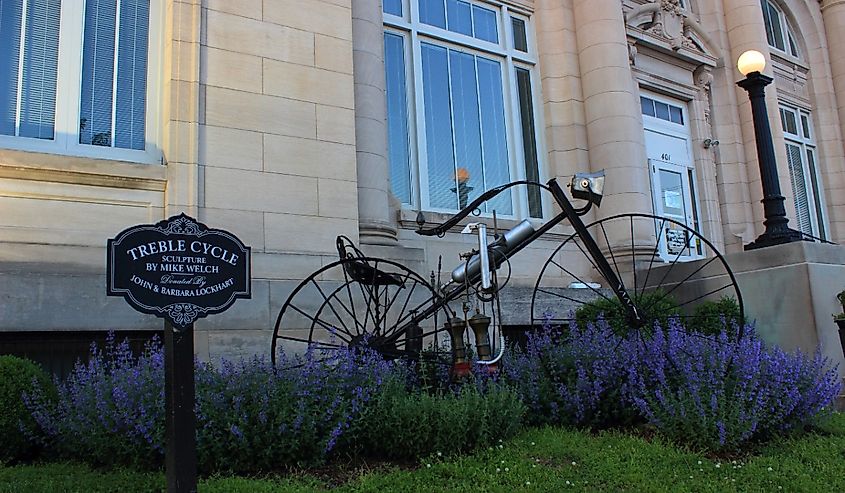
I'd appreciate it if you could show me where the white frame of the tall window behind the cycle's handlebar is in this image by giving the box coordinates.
[382,0,551,220]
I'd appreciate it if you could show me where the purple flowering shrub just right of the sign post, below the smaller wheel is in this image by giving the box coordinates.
[197,344,405,472]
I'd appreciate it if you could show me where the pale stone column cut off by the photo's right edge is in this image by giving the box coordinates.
[820,0,845,243]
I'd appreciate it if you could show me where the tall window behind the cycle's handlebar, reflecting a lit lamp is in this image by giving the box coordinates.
[383,0,543,217]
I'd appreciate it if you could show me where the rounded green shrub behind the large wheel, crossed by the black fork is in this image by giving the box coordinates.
[575,290,681,336]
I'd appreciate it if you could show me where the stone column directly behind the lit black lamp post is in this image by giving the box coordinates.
[723,0,795,233]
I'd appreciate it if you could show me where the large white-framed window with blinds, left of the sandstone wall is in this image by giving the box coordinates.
[0,0,159,162]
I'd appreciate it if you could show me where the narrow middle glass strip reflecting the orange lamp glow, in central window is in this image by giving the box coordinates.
[449,50,482,209]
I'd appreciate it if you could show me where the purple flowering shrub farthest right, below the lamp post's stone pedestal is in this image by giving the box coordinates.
[627,320,841,451]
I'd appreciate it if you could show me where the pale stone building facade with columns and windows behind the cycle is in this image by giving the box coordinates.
[0,0,845,358]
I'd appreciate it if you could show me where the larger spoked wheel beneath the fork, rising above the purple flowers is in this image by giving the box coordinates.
[531,214,744,331]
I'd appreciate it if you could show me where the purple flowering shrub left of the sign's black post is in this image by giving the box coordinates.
[24,334,164,467]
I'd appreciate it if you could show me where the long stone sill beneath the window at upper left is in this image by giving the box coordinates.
[0,149,167,192]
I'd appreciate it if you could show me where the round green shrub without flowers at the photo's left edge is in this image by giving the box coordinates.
[0,356,51,462]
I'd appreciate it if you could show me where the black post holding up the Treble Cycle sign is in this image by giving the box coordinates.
[164,321,197,493]
